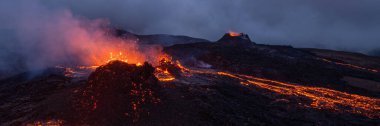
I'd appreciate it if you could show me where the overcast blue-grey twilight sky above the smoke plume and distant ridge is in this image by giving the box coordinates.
[0,0,380,52]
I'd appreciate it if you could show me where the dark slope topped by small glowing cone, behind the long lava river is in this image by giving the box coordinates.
[164,34,380,97]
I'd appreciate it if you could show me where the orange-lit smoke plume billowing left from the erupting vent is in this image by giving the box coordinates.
[0,1,160,77]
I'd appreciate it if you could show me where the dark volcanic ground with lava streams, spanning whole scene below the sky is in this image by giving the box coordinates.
[0,30,380,126]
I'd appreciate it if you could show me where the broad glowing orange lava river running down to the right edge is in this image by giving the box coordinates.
[191,70,380,118]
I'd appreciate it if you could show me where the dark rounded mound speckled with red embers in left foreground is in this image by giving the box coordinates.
[76,61,160,125]
